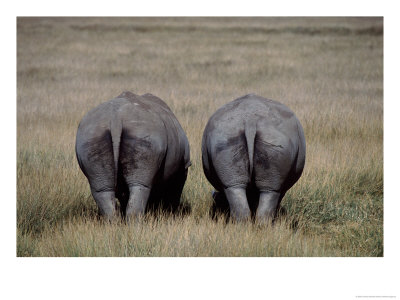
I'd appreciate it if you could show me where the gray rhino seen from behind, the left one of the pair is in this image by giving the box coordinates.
[75,92,190,220]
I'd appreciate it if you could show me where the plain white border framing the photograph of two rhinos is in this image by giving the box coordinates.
[0,0,400,299]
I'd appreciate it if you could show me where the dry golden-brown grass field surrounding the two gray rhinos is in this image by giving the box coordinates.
[16,18,384,256]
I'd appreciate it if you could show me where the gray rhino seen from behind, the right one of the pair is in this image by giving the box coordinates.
[202,94,306,223]
